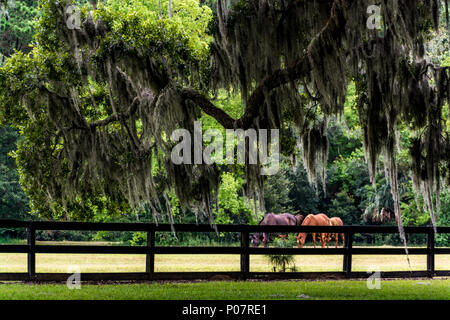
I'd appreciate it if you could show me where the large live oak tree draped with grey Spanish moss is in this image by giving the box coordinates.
[0,0,450,241]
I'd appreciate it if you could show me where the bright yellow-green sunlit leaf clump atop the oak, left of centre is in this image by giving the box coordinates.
[95,1,210,68]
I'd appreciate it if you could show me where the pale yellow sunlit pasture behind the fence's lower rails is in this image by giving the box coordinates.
[0,245,450,273]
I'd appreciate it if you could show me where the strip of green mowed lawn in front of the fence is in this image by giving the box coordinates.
[0,280,450,300]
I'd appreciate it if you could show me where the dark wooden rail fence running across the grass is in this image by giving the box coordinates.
[0,220,450,281]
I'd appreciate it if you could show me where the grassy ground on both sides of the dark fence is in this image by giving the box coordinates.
[0,243,450,300]
